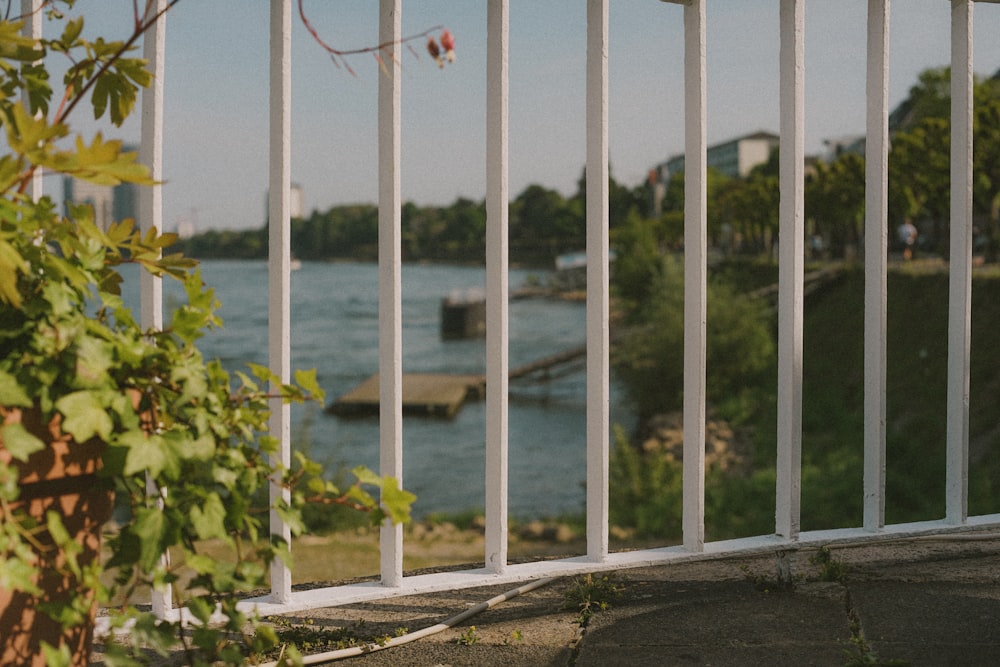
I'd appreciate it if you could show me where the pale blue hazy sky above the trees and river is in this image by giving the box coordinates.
[46,0,1000,231]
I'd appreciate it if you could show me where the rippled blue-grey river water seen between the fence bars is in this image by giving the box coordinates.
[135,261,627,519]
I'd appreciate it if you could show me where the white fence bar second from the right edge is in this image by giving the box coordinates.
[864,0,890,532]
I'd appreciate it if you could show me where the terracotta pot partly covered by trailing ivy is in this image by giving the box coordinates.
[0,408,113,667]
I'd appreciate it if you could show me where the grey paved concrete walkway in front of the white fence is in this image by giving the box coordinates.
[260,533,1000,667]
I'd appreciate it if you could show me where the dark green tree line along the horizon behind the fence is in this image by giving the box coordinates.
[178,67,1000,266]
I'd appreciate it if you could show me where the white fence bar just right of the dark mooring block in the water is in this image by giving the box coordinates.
[485,0,510,574]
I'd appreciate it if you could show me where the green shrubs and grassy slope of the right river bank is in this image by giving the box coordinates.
[611,263,1000,539]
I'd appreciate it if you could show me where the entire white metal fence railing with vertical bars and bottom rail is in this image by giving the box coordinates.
[133,0,1000,613]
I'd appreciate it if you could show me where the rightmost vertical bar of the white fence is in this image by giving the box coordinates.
[945,0,974,524]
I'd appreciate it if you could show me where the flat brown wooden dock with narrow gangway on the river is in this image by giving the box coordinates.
[328,345,587,418]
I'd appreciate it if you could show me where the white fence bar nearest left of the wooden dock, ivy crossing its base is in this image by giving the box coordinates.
[267,0,292,602]
